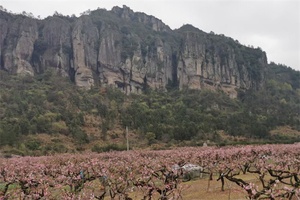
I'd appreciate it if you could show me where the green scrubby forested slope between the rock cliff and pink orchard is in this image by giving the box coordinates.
[0,63,300,155]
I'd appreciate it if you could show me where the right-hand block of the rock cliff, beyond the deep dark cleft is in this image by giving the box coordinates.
[177,25,267,97]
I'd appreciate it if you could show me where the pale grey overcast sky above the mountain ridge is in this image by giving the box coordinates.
[0,0,300,71]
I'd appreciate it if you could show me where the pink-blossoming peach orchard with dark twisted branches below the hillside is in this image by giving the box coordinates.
[0,144,300,200]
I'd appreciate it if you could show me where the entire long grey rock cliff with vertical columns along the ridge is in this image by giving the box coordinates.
[0,6,267,97]
